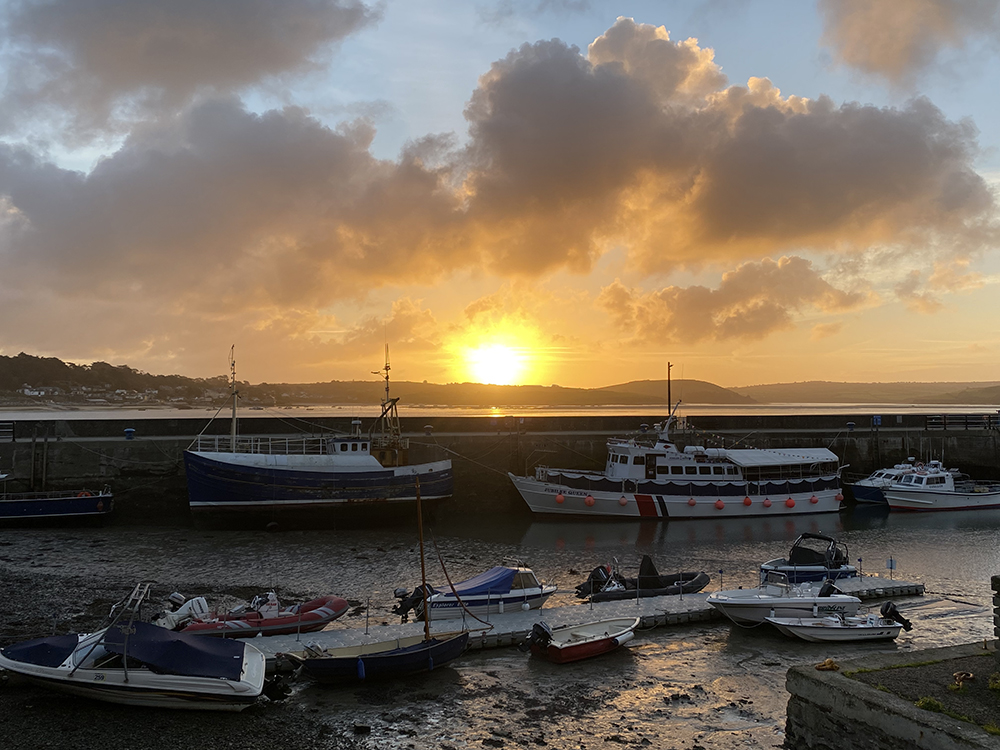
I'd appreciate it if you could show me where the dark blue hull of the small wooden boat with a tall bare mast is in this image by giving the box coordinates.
[285,632,469,685]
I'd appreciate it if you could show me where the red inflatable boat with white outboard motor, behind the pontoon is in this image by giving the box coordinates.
[156,591,350,638]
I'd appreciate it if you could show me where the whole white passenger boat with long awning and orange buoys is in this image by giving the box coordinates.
[509,407,843,520]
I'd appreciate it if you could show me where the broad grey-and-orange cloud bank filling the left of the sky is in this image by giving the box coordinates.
[0,99,474,314]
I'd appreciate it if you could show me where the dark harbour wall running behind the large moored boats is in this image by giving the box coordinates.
[0,407,1000,523]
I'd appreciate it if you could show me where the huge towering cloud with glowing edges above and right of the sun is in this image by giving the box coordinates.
[465,19,996,274]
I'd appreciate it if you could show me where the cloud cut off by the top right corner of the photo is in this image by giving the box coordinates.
[819,0,1000,85]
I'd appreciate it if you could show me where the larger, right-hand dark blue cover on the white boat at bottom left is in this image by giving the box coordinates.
[102,622,246,680]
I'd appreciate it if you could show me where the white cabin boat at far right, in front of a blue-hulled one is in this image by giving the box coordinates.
[883,461,1000,511]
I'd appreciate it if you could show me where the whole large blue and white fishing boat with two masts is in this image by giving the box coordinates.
[184,350,453,521]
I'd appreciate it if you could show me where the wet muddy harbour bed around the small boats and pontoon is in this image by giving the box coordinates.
[0,519,992,750]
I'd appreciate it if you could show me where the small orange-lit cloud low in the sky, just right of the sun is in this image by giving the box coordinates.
[597,257,868,344]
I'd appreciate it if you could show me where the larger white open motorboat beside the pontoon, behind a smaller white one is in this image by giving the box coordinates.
[707,573,861,625]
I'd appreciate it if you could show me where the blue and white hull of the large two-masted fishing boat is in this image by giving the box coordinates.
[184,451,454,520]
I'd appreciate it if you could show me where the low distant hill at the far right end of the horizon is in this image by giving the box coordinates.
[730,380,1000,404]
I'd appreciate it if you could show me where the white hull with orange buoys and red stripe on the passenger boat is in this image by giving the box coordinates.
[508,472,843,520]
